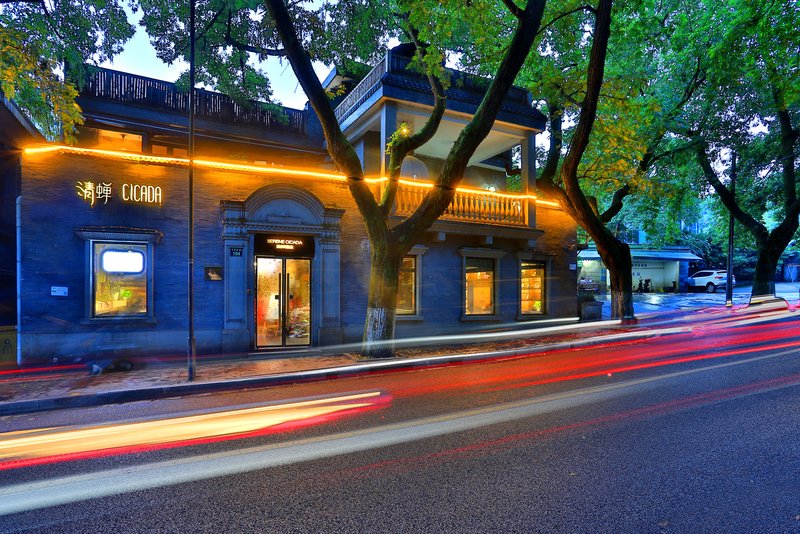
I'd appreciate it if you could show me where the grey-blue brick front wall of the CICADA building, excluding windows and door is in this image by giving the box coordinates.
[18,152,576,361]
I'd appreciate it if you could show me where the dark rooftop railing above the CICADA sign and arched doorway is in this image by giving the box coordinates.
[81,69,305,135]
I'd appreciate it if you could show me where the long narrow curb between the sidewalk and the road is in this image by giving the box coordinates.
[0,327,689,416]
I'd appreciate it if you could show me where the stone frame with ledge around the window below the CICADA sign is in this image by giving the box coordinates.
[76,228,162,324]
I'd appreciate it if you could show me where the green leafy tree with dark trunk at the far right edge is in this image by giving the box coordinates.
[675,0,800,294]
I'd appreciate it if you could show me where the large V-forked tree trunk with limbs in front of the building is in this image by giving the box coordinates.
[266,0,552,358]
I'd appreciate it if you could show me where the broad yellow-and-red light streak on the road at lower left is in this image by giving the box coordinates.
[0,391,389,470]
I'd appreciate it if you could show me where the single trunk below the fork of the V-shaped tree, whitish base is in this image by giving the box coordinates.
[361,247,402,358]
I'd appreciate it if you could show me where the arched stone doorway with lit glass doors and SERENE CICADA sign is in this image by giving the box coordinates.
[222,184,344,350]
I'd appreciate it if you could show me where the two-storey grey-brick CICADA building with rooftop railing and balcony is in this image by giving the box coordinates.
[0,47,577,364]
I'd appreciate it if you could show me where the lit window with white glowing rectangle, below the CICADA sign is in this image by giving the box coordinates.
[91,241,149,317]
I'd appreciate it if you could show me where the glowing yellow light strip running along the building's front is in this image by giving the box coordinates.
[24,145,559,207]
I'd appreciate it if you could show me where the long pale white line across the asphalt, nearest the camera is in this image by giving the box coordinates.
[0,349,798,515]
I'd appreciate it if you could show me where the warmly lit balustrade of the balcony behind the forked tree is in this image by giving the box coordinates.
[381,183,528,226]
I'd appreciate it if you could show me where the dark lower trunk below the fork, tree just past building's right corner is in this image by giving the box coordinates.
[593,239,636,322]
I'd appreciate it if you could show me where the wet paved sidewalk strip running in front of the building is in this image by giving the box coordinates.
[0,295,797,416]
